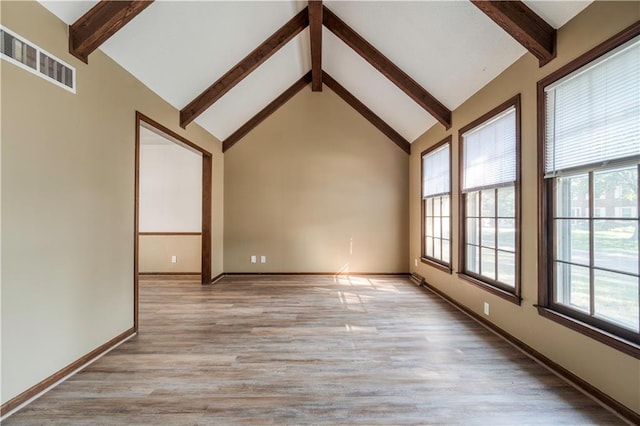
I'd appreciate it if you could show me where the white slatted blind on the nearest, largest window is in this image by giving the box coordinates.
[545,37,640,177]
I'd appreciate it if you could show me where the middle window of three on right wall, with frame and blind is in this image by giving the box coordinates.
[460,95,520,303]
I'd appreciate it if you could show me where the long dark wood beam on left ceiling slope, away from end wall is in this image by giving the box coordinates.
[180,7,309,128]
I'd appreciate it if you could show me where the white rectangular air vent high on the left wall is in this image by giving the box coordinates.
[0,26,76,93]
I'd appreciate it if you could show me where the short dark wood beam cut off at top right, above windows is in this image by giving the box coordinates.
[471,0,556,66]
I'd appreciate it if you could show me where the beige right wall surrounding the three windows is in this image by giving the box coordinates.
[410,2,640,412]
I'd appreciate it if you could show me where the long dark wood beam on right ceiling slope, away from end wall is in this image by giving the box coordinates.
[323,6,451,129]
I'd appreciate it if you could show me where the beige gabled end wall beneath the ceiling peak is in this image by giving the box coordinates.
[224,87,409,272]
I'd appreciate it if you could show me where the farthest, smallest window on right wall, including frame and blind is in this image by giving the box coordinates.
[422,137,451,272]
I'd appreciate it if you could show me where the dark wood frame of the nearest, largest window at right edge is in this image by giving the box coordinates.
[535,22,640,359]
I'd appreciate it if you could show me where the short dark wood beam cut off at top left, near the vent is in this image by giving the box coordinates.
[69,0,153,63]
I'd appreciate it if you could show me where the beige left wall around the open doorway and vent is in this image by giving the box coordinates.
[0,1,223,403]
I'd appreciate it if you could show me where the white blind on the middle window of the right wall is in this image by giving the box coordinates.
[462,106,516,191]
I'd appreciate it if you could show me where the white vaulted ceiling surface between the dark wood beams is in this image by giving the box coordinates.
[41,0,591,142]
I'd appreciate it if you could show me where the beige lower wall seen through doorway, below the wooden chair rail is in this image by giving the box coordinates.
[138,235,201,276]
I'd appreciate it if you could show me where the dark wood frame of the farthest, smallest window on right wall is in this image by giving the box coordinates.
[420,135,453,274]
